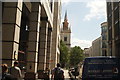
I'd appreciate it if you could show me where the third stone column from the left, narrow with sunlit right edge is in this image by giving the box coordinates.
[38,21,48,71]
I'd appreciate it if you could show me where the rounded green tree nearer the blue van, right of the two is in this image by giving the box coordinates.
[69,46,84,67]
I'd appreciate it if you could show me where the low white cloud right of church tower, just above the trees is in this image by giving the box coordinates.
[71,35,92,49]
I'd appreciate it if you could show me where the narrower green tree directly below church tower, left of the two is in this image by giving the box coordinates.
[60,41,69,67]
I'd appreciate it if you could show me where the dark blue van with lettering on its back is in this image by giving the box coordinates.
[82,56,120,80]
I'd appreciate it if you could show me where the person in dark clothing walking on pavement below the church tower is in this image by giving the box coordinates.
[51,63,64,80]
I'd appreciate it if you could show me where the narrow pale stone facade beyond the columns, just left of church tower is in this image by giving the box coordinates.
[51,0,61,69]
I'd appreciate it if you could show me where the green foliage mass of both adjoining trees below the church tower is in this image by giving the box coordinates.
[60,41,84,68]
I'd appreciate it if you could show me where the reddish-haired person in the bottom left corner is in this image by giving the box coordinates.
[1,64,14,80]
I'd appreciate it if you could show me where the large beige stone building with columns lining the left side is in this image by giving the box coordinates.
[1,0,61,80]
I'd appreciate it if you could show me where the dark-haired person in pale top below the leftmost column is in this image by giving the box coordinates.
[10,61,22,80]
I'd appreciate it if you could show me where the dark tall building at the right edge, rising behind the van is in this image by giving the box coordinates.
[107,0,120,57]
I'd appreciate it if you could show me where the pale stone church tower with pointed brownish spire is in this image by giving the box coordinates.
[61,11,71,49]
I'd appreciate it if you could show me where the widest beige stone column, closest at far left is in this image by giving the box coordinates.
[2,1,23,66]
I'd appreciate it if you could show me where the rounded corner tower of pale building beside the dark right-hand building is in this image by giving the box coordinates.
[101,22,109,56]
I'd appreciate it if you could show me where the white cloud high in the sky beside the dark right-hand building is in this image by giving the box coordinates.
[83,0,106,21]
